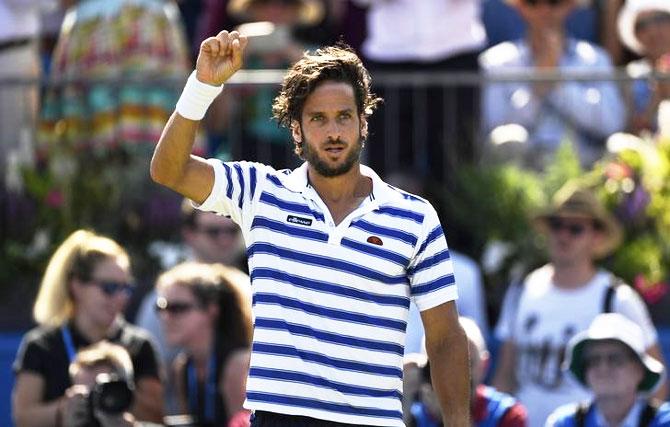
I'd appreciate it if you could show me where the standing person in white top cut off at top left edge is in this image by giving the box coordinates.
[0,0,58,182]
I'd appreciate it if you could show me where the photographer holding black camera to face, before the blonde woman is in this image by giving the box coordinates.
[61,341,139,427]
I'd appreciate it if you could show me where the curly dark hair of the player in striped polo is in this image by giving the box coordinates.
[272,43,382,147]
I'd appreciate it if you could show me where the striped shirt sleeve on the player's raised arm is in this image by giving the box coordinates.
[195,159,271,230]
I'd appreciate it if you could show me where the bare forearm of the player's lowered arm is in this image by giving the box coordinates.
[426,324,471,427]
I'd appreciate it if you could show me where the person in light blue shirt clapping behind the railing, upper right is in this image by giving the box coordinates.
[480,0,626,168]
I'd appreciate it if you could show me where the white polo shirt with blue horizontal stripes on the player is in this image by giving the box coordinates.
[199,159,457,426]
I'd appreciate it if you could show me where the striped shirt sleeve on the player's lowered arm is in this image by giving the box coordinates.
[408,205,458,311]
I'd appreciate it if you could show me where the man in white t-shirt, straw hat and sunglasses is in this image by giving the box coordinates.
[493,186,665,427]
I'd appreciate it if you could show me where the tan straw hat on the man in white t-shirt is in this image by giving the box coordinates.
[532,185,624,258]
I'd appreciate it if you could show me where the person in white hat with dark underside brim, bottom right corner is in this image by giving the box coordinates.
[546,313,670,427]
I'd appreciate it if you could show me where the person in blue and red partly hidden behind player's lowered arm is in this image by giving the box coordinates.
[409,317,527,427]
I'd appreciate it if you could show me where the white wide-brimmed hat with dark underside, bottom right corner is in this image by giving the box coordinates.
[563,313,665,393]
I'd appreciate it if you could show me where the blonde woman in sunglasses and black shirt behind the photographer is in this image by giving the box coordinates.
[12,230,163,427]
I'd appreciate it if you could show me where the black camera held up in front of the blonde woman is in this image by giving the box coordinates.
[84,374,134,427]
